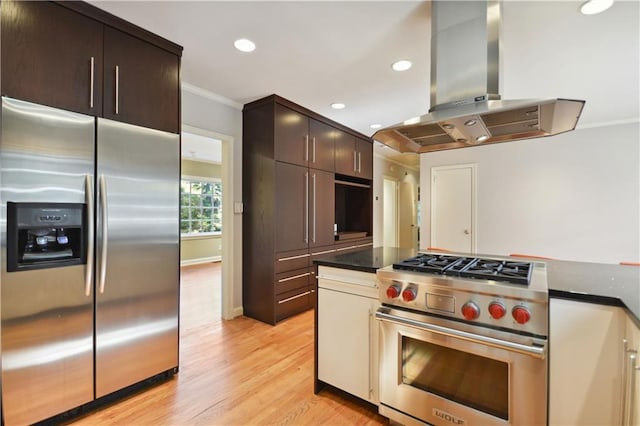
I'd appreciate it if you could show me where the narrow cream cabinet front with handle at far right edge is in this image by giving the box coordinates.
[622,316,640,426]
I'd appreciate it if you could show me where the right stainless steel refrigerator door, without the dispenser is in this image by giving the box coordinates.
[95,119,180,397]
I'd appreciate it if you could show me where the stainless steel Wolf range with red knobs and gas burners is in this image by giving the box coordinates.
[376,253,549,425]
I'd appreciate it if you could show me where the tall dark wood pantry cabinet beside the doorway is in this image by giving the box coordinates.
[243,95,373,324]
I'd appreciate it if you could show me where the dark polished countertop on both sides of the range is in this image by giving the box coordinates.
[315,247,640,327]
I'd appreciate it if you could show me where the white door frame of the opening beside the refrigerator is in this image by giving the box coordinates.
[181,124,238,320]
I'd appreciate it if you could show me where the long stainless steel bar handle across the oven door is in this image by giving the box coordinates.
[376,310,547,359]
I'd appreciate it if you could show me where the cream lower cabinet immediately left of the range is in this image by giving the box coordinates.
[316,266,380,405]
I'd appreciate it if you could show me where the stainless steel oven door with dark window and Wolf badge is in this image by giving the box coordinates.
[376,307,547,425]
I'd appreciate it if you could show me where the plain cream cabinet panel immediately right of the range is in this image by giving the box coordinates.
[549,298,625,426]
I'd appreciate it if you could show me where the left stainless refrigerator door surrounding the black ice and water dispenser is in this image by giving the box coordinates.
[0,98,95,425]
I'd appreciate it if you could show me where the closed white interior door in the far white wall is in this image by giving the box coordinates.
[430,164,476,253]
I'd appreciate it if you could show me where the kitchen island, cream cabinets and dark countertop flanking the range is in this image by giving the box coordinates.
[315,247,640,424]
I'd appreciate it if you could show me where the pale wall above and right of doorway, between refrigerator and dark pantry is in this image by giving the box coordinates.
[182,85,242,314]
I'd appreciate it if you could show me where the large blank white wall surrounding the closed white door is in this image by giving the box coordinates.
[420,123,640,263]
